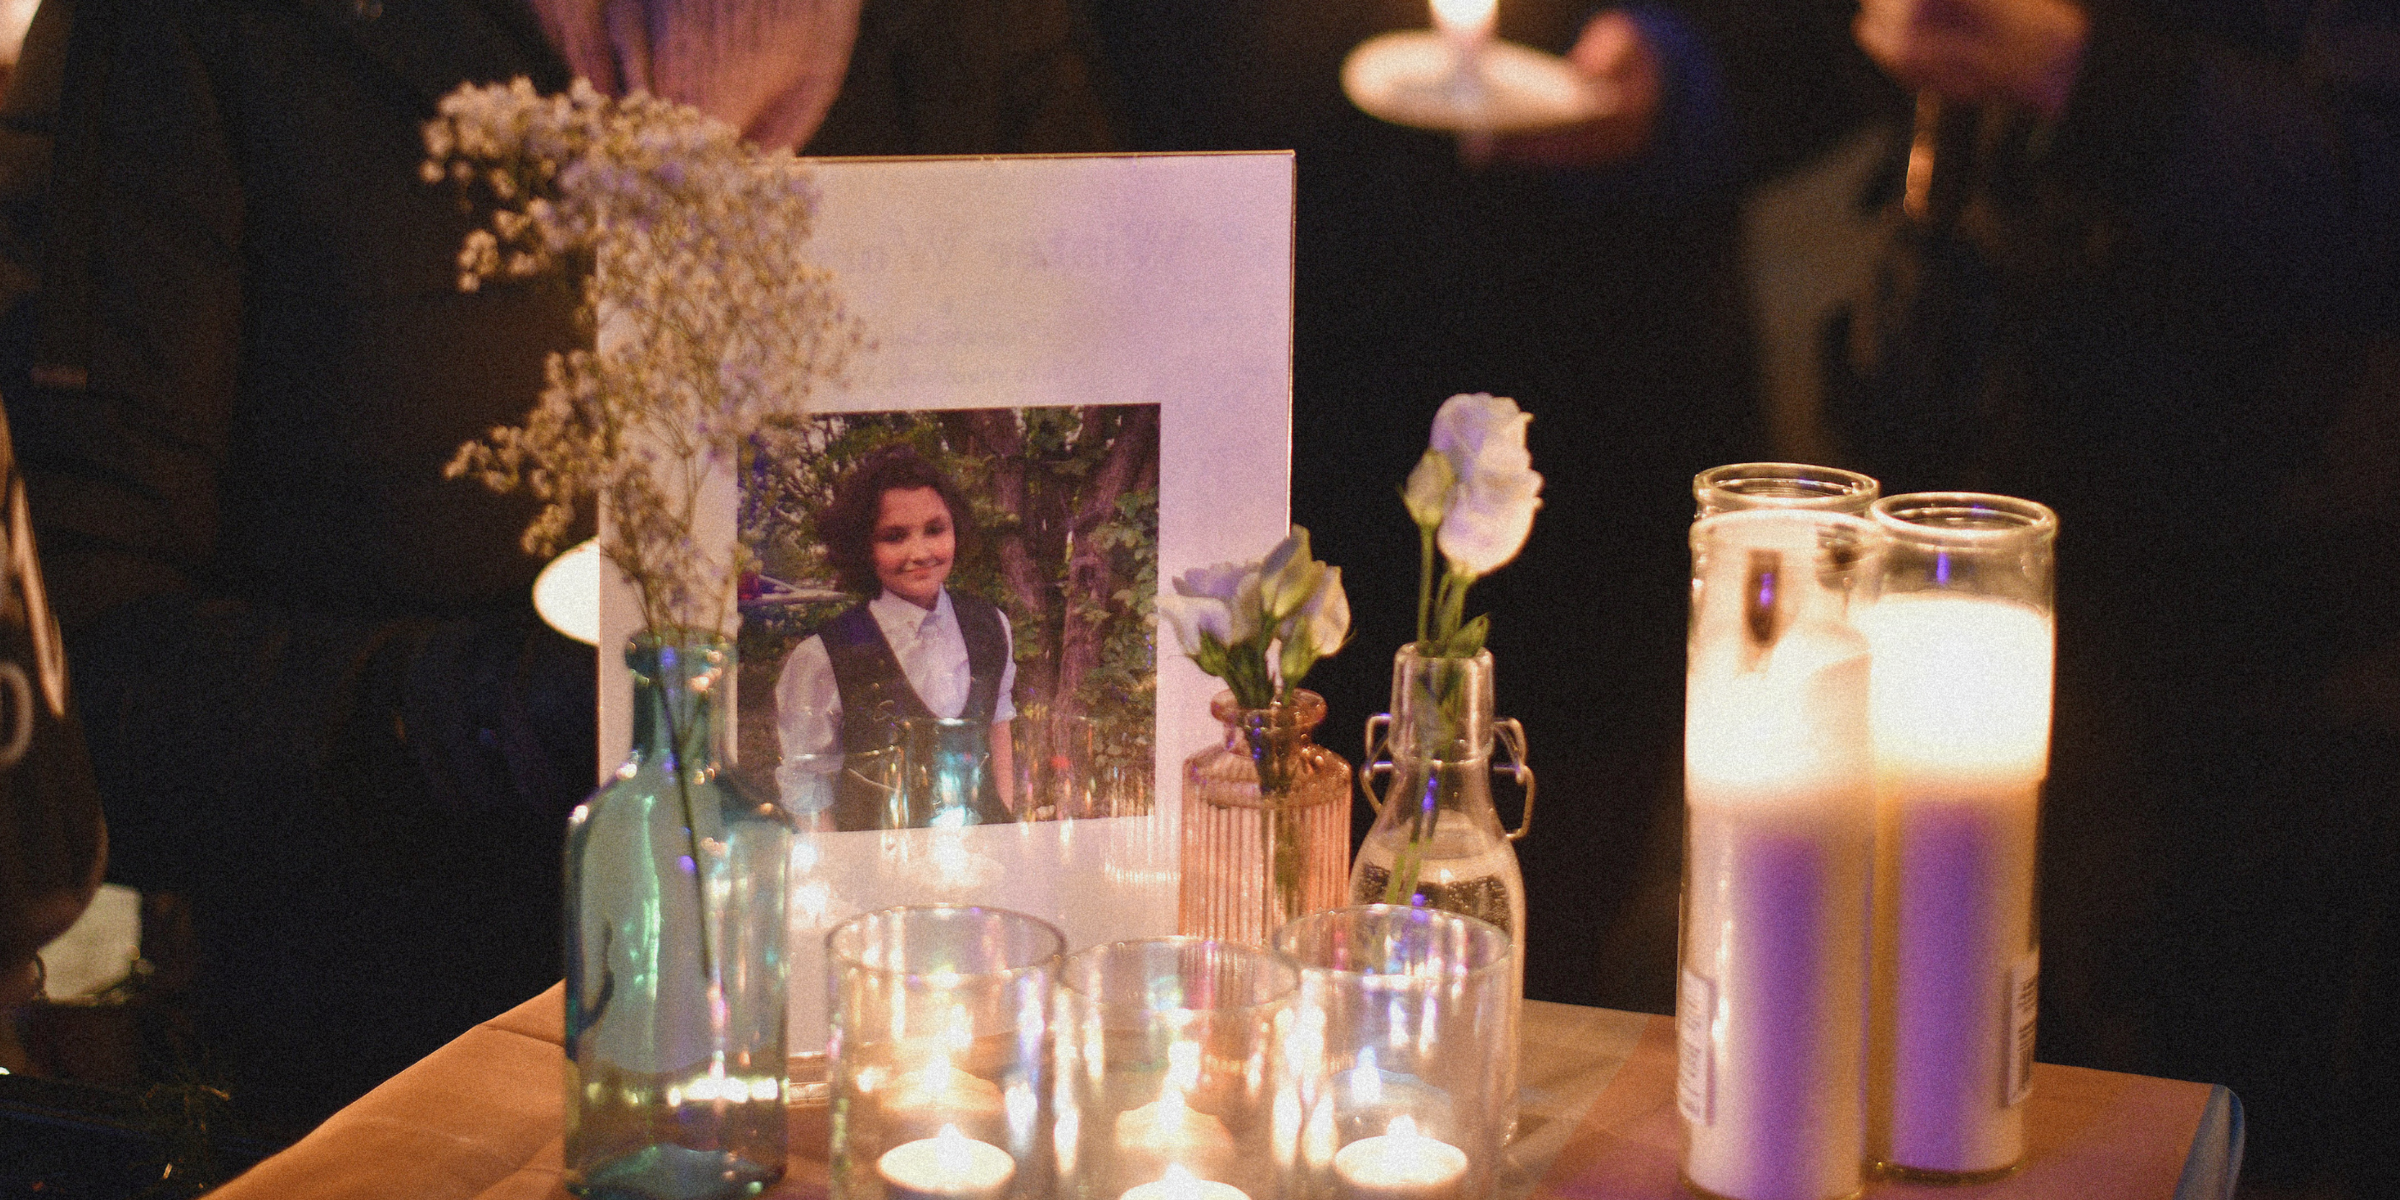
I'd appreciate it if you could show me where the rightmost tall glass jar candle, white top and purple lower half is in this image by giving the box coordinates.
[1860,492,2059,1183]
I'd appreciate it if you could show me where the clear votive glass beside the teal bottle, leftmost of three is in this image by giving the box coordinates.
[826,905,1066,1200]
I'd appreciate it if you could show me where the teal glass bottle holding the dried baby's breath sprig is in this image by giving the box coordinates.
[564,634,792,1200]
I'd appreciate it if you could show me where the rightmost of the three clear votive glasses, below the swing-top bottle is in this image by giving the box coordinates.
[1274,905,1517,1200]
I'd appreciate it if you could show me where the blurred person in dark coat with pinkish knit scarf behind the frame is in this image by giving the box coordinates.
[0,0,1109,1130]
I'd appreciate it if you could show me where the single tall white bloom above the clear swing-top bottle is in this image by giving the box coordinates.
[1411,391,1541,578]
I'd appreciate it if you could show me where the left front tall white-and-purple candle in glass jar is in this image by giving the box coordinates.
[1675,511,1879,1200]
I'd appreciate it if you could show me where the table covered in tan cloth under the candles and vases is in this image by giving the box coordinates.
[196,986,2242,1200]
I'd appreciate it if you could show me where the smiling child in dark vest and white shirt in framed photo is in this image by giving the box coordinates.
[775,444,1018,830]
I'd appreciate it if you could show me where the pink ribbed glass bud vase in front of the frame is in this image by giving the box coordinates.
[1176,689,1349,946]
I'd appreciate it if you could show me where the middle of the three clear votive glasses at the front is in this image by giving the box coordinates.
[1051,938,1298,1200]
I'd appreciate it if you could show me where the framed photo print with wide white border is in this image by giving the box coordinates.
[600,154,1294,1046]
